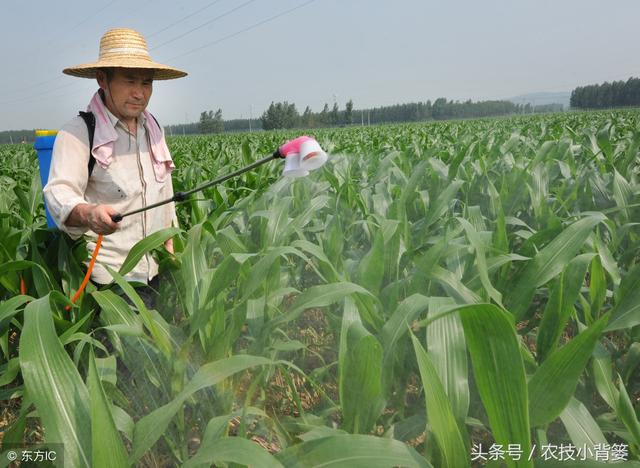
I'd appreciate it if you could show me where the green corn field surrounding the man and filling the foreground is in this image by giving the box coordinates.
[0,110,640,468]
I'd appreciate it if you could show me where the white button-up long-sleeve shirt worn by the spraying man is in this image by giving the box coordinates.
[44,110,178,284]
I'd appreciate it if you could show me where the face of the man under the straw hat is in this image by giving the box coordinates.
[96,68,153,123]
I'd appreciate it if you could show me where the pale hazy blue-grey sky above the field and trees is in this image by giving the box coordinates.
[0,0,640,130]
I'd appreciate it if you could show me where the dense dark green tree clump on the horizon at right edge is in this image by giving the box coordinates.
[569,77,640,109]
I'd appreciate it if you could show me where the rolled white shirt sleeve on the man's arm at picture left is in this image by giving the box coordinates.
[43,120,89,239]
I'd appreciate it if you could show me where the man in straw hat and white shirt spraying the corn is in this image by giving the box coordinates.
[44,29,186,296]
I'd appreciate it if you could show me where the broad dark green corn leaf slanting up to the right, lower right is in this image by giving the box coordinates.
[529,314,609,427]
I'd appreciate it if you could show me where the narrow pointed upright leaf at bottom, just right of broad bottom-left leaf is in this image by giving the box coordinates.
[87,351,128,468]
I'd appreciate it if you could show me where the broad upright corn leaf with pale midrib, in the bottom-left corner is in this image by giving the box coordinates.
[20,295,92,467]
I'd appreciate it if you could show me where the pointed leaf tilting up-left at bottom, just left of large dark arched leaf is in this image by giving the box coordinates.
[411,335,469,468]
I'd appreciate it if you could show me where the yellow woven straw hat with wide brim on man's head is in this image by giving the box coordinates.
[62,28,187,80]
